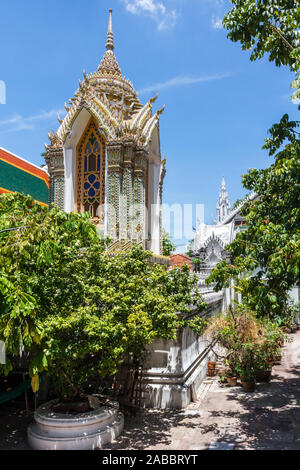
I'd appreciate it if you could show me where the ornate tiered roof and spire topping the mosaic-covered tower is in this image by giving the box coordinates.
[46,10,164,151]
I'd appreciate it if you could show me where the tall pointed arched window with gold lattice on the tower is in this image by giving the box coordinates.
[76,119,105,218]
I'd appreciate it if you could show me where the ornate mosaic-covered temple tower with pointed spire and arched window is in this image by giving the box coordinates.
[45,10,165,254]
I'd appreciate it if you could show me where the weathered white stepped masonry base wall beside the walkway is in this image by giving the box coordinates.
[143,292,223,409]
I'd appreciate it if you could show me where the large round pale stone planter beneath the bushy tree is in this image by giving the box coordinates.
[27,400,124,450]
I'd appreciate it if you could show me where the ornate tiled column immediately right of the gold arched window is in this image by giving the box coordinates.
[106,142,123,240]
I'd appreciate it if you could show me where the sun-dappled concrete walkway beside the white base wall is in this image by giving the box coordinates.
[106,332,300,450]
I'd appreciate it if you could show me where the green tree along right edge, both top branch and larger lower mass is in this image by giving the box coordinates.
[207,0,300,317]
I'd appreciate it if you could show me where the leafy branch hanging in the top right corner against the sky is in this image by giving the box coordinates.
[223,0,300,103]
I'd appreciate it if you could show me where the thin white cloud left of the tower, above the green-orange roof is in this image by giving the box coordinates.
[0,110,65,134]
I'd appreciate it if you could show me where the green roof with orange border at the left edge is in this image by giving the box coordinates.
[0,147,49,206]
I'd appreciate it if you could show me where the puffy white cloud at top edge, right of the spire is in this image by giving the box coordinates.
[121,0,178,31]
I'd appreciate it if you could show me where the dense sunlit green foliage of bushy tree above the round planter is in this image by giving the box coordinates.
[0,194,204,397]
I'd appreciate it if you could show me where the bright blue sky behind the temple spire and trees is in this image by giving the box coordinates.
[0,0,297,250]
